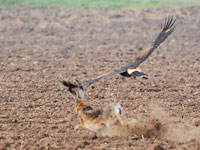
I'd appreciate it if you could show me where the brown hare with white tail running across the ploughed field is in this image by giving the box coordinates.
[63,81,128,132]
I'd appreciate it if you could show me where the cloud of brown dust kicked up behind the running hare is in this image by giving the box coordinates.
[101,105,200,142]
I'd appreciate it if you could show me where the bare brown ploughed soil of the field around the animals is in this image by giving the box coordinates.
[0,6,200,150]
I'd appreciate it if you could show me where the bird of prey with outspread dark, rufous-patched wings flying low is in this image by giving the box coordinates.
[62,16,176,98]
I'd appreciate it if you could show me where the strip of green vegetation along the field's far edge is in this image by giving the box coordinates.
[0,0,200,8]
